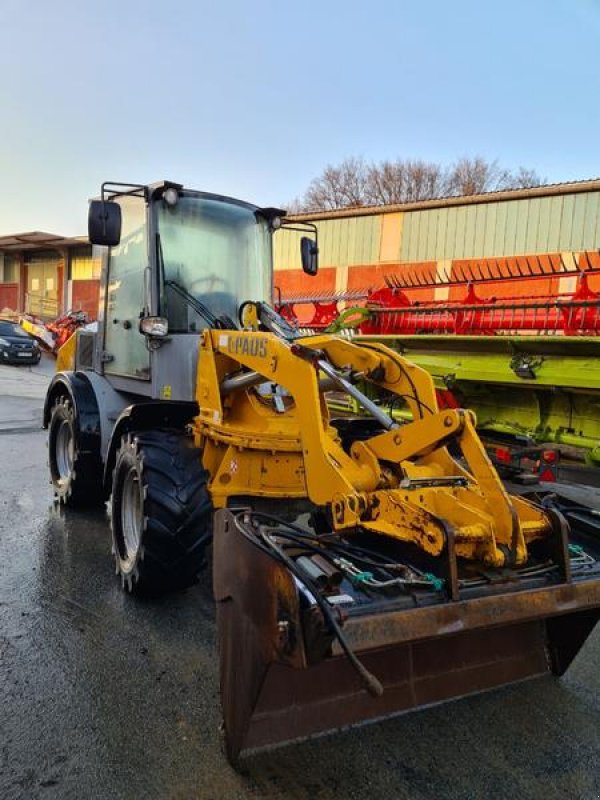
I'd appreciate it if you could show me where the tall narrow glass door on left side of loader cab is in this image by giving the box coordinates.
[104,196,151,381]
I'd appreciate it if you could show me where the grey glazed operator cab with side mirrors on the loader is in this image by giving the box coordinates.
[88,182,318,400]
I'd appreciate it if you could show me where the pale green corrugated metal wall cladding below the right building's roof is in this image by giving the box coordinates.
[275,191,600,276]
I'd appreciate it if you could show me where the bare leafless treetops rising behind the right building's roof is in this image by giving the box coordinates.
[291,156,544,211]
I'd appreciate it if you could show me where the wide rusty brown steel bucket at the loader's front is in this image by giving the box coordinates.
[214,510,600,765]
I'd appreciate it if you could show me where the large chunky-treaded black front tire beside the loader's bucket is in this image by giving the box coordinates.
[111,431,213,593]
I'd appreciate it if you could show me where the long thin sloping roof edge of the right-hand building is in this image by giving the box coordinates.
[289,178,600,220]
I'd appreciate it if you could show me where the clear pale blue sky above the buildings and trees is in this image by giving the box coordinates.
[0,0,600,235]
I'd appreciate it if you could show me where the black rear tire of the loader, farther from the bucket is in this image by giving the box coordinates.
[48,395,104,508]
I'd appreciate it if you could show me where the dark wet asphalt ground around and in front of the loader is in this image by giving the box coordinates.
[0,362,600,800]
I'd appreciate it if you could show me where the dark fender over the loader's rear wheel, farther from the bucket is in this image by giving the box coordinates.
[43,371,101,457]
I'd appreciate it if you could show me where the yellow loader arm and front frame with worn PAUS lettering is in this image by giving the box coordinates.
[195,330,551,567]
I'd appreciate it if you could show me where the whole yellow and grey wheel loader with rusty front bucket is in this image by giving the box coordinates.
[44,182,600,764]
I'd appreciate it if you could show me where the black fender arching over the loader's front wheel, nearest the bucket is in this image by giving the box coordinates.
[104,400,200,497]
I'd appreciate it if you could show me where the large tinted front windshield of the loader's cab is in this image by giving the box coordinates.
[157,193,272,333]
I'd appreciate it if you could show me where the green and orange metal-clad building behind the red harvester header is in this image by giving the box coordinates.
[275,180,600,312]
